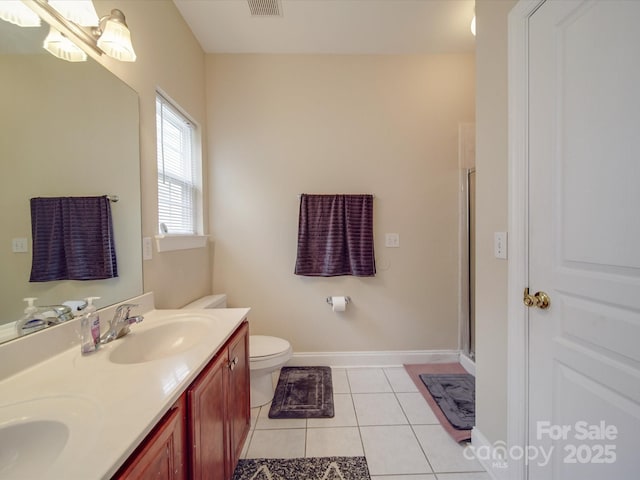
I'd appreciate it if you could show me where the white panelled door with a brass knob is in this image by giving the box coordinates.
[528,0,640,480]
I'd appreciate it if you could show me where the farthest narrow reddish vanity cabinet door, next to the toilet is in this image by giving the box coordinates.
[227,323,251,478]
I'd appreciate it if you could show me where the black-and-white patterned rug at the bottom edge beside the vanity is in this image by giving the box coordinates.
[233,457,371,480]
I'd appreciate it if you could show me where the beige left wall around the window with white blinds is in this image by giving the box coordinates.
[94,0,211,308]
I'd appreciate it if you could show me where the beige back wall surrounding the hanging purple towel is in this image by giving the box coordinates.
[207,55,475,352]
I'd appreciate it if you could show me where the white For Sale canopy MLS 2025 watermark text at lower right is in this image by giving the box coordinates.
[463,420,618,468]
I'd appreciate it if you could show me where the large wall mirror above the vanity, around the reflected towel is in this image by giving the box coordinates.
[0,20,143,342]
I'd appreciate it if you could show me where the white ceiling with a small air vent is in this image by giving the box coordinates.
[173,0,475,54]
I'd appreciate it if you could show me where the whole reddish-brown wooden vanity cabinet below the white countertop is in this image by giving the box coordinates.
[114,321,251,480]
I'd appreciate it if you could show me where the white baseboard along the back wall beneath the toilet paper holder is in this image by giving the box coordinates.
[287,350,460,367]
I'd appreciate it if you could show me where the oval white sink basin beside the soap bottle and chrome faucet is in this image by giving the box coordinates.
[109,318,209,364]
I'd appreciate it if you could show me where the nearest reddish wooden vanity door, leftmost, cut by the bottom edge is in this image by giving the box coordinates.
[114,395,187,480]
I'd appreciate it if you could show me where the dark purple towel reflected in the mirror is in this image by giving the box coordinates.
[30,196,118,282]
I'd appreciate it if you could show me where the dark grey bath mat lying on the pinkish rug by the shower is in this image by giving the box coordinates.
[420,373,476,430]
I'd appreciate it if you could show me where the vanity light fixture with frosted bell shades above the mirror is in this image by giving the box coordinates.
[18,0,136,62]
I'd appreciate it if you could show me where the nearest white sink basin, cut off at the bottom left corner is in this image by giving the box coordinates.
[0,396,99,478]
